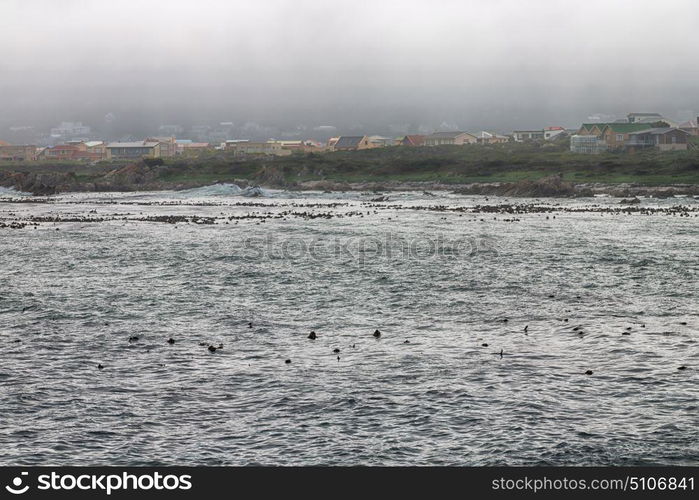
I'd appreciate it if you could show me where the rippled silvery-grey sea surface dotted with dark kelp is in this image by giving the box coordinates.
[0,186,699,465]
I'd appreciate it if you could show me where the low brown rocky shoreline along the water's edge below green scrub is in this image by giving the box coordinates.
[0,162,699,198]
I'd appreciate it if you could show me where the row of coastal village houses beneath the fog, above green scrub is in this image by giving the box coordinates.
[0,113,699,162]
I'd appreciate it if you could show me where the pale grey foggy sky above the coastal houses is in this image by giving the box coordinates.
[0,0,699,133]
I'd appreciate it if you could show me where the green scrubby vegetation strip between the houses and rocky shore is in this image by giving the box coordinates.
[0,138,699,191]
